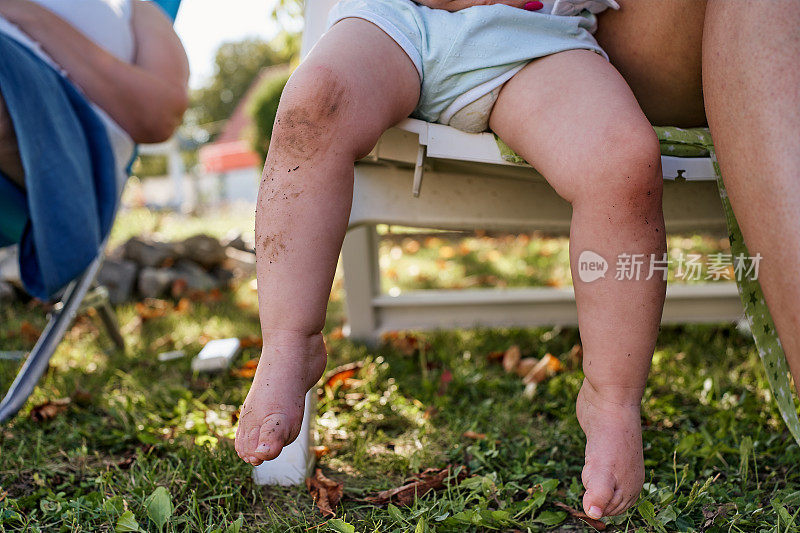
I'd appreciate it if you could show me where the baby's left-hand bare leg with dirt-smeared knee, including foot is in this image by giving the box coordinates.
[236,19,419,465]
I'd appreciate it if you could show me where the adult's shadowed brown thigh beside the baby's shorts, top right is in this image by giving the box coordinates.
[595,0,708,127]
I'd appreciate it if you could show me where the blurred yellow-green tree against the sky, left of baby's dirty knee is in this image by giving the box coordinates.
[185,34,299,136]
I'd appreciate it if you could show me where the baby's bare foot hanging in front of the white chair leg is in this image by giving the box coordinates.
[236,331,328,466]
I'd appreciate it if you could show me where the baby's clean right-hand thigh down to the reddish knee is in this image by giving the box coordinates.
[490,50,663,208]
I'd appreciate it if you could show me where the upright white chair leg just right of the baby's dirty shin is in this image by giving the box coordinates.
[342,226,380,346]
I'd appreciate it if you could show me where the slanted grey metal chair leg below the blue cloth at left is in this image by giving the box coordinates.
[0,257,102,422]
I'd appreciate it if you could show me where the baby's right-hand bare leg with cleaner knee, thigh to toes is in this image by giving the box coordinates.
[490,50,666,518]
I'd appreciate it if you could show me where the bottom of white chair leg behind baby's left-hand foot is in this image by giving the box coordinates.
[253,388,317,486]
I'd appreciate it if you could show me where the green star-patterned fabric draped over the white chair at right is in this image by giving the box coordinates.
[495,123,800,444]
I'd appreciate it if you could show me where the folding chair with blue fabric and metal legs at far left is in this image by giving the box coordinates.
[0,0,181,422]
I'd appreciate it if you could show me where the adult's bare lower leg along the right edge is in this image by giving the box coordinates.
[703,0,800,390]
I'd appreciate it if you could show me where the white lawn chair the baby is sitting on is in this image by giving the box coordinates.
[255,0,742,481]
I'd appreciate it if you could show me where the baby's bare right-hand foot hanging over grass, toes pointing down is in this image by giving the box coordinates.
[576,380,644,518]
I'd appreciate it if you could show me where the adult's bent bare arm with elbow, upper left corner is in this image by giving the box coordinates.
[0,0,189,143]
